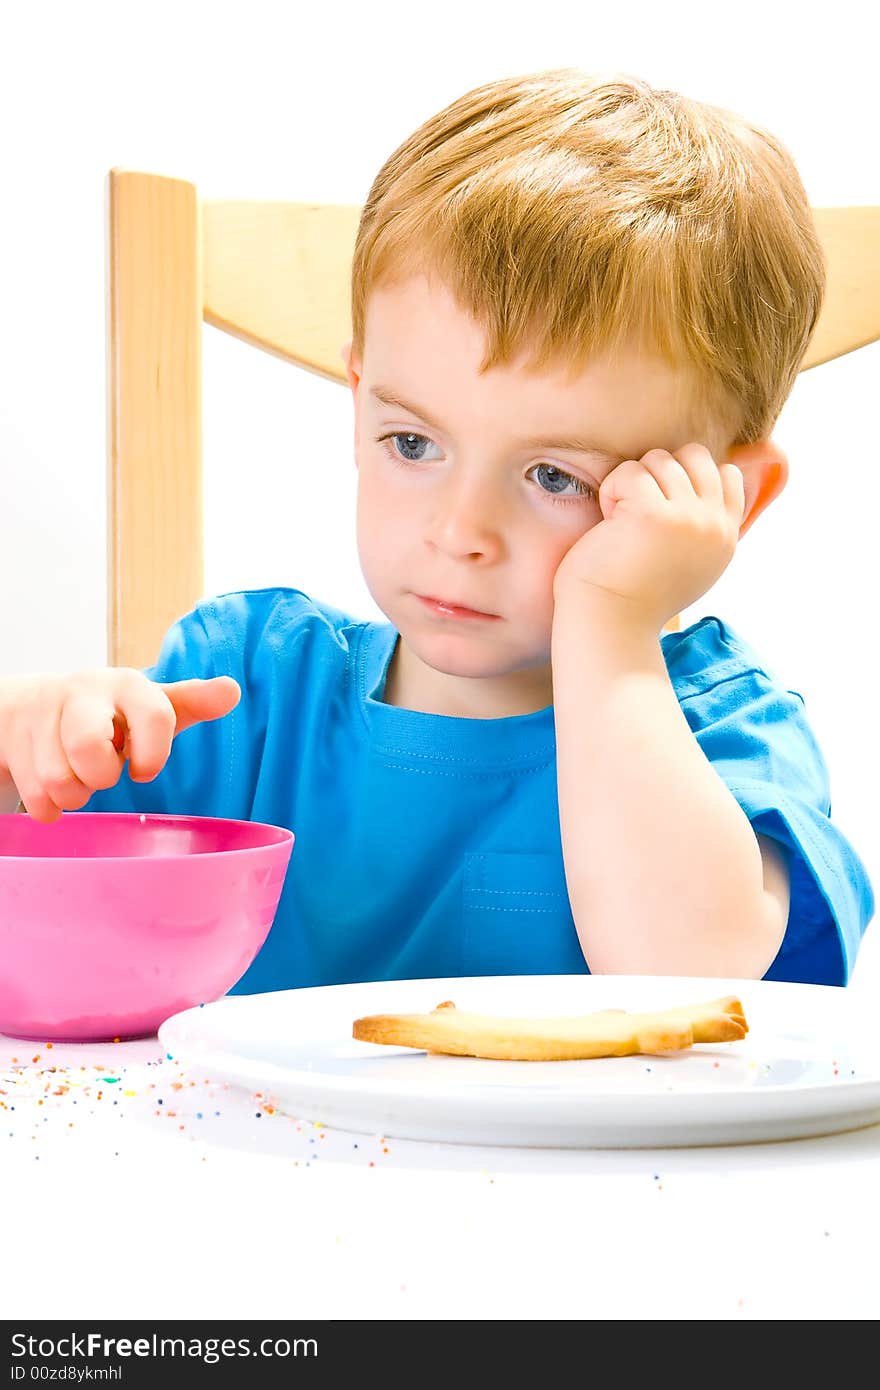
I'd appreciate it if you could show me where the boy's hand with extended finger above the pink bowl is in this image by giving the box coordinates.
[0,667,241,821]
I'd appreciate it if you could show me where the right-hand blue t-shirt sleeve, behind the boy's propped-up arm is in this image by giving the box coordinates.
[665,619,874,984]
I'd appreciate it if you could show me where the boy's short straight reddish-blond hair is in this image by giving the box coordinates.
[352,68,826,443]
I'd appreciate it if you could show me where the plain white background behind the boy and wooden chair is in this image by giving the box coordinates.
[0,0,880,978]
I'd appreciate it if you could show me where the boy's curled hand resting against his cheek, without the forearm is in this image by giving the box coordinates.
[553,443,745,631]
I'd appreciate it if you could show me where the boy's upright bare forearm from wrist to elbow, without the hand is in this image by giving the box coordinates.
[552,600,788,979]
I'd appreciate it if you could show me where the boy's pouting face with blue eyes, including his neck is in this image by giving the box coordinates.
[343,277,724,717]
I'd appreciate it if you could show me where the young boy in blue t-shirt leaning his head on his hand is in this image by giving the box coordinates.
[0,70,873,992]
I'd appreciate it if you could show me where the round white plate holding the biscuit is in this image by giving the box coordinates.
[158,976,880,1148]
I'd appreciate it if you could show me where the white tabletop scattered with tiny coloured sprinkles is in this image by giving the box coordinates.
[6,927,880,1321]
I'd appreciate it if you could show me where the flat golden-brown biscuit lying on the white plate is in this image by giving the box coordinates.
[352,995,748,1062]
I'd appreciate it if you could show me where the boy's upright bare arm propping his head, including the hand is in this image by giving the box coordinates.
[551,442,788,977]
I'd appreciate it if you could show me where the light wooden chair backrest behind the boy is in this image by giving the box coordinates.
[107,170,880,667]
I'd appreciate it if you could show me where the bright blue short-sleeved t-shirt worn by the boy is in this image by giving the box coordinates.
[85,588,873,994]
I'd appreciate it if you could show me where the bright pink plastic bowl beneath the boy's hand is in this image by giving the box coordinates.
[0,812,293,1043]
